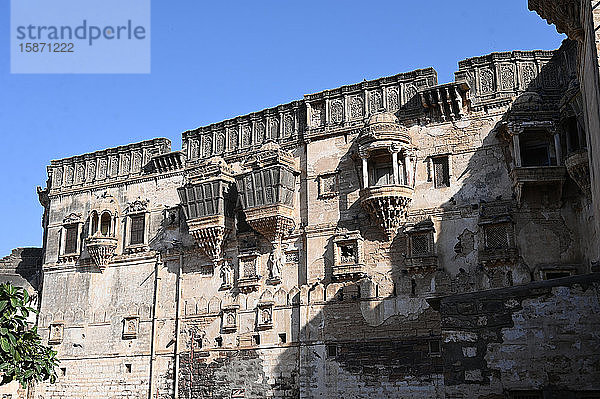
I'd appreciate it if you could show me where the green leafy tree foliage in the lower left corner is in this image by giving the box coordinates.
[0,283,58,387]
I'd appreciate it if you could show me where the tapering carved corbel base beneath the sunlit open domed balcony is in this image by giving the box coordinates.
[360,185,414,239]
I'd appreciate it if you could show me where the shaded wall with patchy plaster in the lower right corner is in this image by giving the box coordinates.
[439,274,600,398]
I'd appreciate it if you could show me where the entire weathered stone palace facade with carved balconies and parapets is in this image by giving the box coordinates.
[0,0,600,399]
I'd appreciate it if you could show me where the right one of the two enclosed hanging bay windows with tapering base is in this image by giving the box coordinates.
[235,142,299,266]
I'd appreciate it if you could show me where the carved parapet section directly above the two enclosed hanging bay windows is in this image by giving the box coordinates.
[183,101,305,164]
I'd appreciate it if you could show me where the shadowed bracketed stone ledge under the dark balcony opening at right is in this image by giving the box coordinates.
[510,166,567,205]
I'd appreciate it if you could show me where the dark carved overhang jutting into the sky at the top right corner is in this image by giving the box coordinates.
[528,0,584,41]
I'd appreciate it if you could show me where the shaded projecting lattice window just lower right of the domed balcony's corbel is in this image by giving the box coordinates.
[404,219,438,274]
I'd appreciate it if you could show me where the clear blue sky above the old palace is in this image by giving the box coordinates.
[0,0,564,256]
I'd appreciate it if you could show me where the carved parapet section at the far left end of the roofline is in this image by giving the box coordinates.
[48,138,171,194]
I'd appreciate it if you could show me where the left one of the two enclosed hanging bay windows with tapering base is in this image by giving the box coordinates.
[177,158,237,266]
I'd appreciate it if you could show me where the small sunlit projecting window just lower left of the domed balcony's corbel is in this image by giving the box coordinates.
[332,231,367,280]
